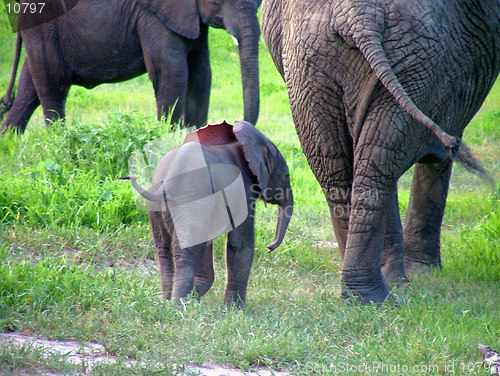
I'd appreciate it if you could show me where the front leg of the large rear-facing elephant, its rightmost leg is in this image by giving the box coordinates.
[404,160,453,274]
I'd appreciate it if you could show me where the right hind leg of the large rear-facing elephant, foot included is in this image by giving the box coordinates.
[342,111,411,303]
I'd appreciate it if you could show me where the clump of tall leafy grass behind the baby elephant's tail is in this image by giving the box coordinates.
[0,113,160,230]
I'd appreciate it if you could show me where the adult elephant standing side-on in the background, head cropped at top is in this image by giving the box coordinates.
[0,0,260,132]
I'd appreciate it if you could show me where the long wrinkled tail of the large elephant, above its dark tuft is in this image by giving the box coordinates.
[356,35,461,149]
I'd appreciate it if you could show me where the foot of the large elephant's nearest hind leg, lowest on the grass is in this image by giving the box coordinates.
[341,271,389,304]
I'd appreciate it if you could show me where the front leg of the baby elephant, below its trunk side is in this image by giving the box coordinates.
[224,213,255,307]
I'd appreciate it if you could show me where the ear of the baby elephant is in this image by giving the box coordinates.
[233,121,278,191]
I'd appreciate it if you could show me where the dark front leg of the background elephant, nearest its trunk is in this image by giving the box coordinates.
[184,31,212,128]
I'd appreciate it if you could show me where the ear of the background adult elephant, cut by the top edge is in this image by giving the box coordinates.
[137,0,200,39]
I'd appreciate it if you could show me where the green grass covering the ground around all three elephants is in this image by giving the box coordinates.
[0,7,500,375]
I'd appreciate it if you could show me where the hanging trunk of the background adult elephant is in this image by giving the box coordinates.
[224,1,260,125]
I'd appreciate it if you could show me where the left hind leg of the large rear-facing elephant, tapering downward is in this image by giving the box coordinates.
[290,84,353,259]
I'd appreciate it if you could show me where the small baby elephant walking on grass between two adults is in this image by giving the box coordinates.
[123,121,293,307]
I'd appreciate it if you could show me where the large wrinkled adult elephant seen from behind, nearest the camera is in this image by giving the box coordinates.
[261,0,500,302]
